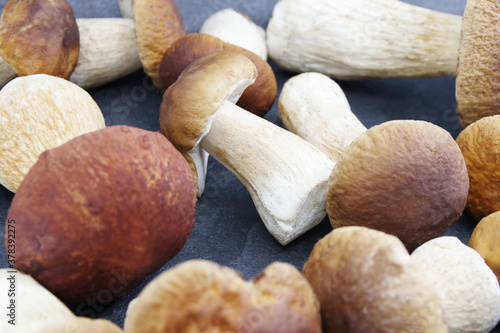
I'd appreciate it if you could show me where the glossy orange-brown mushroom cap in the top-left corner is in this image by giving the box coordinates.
[0,0,80,79]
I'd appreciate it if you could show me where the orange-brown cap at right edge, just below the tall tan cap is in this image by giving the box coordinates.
[456,115,500,221]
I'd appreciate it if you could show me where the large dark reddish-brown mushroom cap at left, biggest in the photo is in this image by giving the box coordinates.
[6,126,196,302]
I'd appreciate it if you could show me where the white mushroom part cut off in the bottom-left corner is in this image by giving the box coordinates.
[0,268,75,333]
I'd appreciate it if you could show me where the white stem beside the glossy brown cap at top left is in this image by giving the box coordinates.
[0,18,142,89]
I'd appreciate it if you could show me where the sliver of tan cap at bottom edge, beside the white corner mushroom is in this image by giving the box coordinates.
[36,317,123,333]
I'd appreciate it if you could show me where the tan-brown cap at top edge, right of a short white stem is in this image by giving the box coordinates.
[132,0,186,87]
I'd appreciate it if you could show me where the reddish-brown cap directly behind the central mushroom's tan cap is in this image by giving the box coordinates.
[159,33,278,116]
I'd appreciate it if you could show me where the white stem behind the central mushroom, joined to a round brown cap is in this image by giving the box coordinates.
[278,73,366,161]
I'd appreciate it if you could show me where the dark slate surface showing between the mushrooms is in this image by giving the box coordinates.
[0,0,500,332]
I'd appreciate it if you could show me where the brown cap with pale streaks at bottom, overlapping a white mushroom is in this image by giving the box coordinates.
[302,227,447,333]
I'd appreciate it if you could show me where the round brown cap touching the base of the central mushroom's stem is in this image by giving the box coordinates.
[327,120,469,251]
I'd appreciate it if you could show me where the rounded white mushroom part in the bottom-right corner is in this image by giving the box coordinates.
[411,237,500,333]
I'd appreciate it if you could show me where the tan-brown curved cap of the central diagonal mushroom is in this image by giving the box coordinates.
[160,52,257,187]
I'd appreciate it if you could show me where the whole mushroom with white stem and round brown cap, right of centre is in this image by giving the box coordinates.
[278,73,469,250]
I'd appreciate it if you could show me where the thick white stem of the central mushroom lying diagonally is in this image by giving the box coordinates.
[200,101,333,245]
